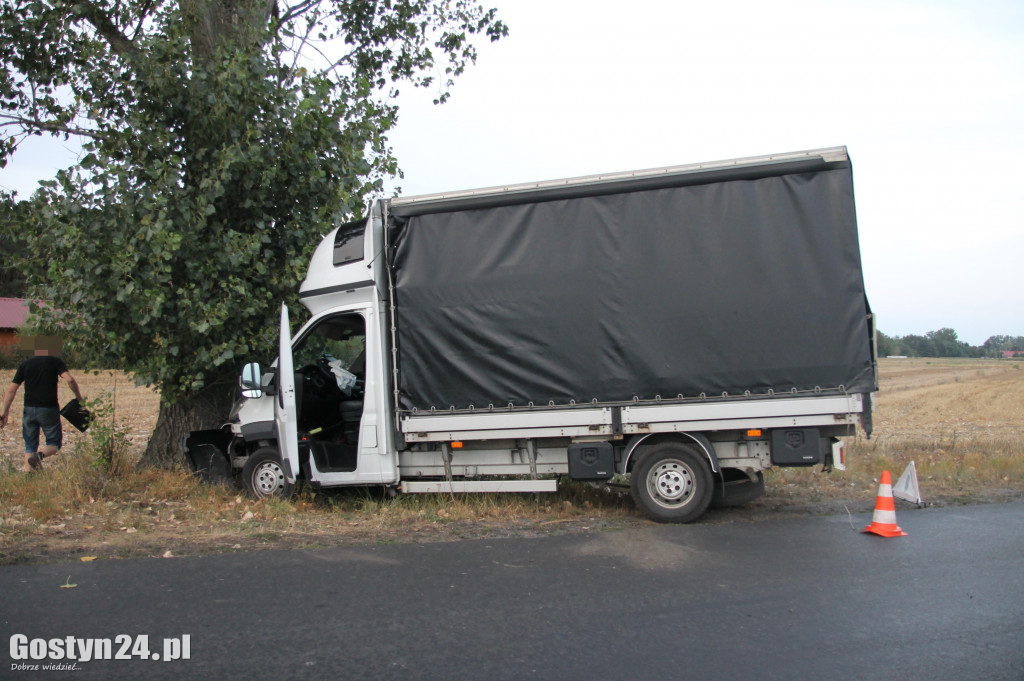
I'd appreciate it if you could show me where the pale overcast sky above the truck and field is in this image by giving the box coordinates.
[0,0,1024,345]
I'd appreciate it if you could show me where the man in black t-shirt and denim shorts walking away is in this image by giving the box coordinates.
[0,336,82,470]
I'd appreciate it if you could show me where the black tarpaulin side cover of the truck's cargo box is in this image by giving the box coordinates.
[389,150,874,411]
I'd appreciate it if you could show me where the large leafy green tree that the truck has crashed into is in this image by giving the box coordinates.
[0,0,507,463]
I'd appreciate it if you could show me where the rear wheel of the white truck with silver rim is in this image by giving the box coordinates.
[630,442,714,522]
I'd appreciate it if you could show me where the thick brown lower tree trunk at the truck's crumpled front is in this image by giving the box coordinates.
[139,376,236,468]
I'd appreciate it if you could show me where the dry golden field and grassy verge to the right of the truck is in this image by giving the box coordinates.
[767,359,1024,509]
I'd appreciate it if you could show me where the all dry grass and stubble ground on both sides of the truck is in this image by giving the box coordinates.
[0,359,1024,563]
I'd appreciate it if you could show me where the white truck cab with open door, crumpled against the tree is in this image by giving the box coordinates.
[221,205,397,497]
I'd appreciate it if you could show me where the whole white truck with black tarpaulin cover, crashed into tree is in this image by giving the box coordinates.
[184,147,877,522]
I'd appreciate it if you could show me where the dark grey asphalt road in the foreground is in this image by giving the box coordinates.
[0,503,1024,681]
